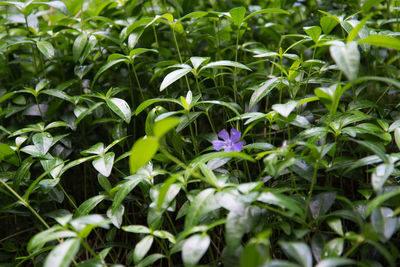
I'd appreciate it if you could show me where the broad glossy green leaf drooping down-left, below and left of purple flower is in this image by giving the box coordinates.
[185,188,220,230]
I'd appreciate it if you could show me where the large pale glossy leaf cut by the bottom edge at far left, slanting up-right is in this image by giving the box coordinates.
[43,238,80,267]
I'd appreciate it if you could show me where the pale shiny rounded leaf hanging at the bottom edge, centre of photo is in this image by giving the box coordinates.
[182,234,211,267]
